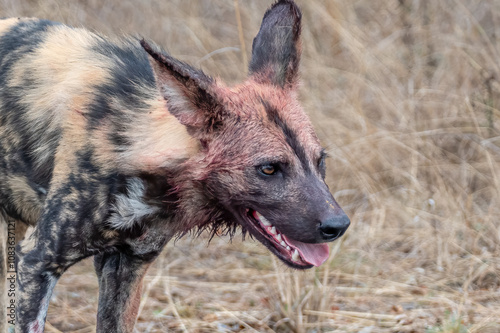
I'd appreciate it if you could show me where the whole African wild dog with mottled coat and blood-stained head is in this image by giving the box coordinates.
[0,0,349,332]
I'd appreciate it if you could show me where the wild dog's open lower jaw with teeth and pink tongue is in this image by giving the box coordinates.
[246,209,330,269]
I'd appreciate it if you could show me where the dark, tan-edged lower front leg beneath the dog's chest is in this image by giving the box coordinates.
[94,252,157,333]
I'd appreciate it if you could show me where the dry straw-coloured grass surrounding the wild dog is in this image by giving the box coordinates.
[0,0,500,333]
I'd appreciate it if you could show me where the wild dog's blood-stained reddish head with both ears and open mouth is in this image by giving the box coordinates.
[142,0,349,268]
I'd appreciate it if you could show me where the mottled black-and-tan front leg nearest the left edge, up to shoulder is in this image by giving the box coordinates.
[16,168,118,333]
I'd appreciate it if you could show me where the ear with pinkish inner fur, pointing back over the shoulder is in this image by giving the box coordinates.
[141,39,223,139]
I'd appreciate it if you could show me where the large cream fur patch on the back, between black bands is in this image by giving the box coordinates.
[8,26,110,171]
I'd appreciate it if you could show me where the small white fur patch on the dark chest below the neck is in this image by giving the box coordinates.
[108,178,158,229]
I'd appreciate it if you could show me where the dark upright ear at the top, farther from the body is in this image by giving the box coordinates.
[249,0,302,88]
